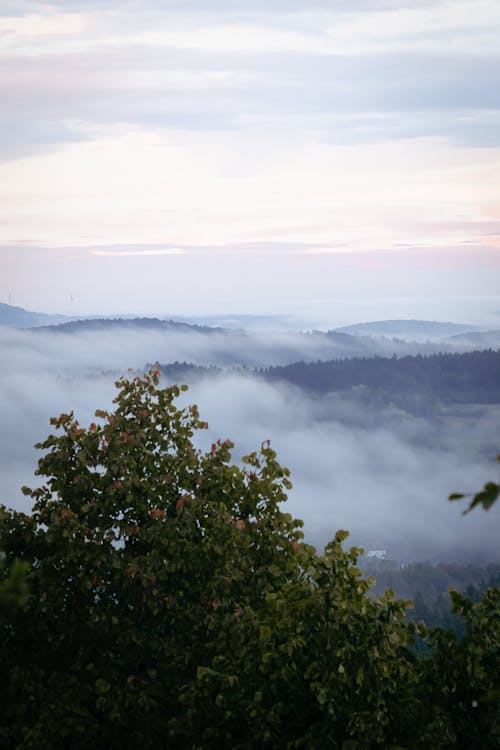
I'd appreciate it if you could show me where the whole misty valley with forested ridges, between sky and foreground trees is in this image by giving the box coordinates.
[0,304,500,563]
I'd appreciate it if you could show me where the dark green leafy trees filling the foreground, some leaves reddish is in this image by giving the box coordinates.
[0,372,500,750]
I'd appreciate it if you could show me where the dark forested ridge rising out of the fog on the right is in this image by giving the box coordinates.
[156,349,500,416]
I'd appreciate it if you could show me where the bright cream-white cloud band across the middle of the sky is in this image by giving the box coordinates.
[0,125,497,250]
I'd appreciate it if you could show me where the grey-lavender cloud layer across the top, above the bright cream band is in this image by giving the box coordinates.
[0,0,500,154]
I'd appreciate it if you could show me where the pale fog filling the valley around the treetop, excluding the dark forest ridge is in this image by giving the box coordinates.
[0,330,500,562]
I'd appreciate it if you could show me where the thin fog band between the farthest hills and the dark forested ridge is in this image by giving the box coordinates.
[0,320,500,377]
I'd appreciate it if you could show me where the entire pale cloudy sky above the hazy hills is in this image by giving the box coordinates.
[0,0,500,327]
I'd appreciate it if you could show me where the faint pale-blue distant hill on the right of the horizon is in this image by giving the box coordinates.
[336,320,479,341]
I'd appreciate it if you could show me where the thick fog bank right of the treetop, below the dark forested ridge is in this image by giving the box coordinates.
[146,375,498,560]
